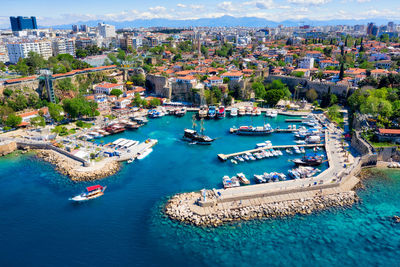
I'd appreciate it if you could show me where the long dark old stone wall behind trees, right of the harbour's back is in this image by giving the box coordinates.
[265,75,350,99]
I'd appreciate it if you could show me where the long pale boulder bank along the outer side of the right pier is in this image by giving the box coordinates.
[164,191,358,227]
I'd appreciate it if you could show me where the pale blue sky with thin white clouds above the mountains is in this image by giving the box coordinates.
[0,0,400,28]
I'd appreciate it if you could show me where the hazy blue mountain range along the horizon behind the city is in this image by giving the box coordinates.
[47,16,396,29]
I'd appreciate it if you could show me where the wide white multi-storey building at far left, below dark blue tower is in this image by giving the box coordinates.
[7,41,53,64]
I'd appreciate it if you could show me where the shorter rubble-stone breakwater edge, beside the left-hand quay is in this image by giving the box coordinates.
[36,150,120,181]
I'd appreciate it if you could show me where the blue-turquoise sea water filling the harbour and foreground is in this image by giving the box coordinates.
[0,115,400,266]
